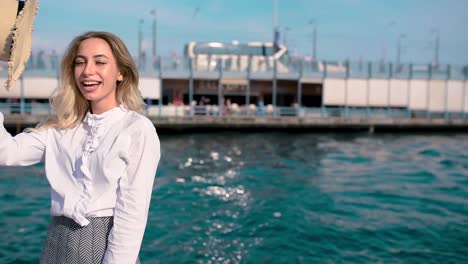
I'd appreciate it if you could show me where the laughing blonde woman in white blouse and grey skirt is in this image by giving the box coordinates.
[0,32,160,263]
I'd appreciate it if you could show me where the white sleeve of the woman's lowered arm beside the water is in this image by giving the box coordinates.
[103,119,160,264]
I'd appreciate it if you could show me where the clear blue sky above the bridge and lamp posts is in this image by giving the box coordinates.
[33,0,468,64]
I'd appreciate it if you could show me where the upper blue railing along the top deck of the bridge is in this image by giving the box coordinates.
[0,55,468,80]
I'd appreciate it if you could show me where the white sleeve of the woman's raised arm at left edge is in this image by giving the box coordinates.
[0,113,47,166]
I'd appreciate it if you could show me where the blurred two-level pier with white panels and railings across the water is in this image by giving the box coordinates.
[0,43,468,133]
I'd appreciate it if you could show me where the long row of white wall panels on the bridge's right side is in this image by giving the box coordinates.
[323,78,468,112]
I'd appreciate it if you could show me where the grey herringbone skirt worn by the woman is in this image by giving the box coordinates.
[41,216,140,264]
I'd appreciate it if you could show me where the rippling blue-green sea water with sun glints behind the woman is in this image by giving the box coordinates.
[0,132,468,263]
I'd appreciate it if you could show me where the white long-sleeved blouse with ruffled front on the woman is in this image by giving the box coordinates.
[0,105,160,263]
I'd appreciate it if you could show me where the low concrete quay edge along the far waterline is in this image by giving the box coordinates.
[4,114,468,133]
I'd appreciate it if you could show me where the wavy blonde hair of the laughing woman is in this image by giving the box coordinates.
[39,31,144,129]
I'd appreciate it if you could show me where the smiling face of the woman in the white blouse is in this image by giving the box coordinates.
[74,38,123,114]
